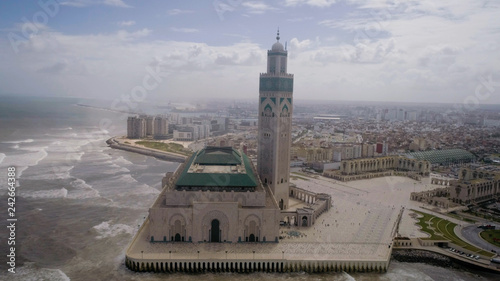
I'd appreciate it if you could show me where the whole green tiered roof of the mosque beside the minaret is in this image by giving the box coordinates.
[175,147,257,187]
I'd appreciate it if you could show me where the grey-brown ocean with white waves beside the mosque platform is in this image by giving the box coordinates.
[0,94,498,281]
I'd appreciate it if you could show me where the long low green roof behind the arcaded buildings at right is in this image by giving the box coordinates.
[406,149,476,164]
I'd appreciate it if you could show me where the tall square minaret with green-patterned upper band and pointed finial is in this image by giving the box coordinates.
[257,30,293,210]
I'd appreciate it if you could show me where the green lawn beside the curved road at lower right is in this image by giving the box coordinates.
[412,210,493,257]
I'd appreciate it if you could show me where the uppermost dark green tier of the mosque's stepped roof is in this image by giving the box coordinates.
[194,147,241,166]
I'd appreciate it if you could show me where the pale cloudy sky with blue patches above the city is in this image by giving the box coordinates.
[0,0,500,103]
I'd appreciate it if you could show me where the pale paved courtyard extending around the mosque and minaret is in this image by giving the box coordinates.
[128,172,446,260]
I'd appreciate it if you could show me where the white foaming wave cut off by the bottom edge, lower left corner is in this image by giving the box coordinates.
[9,262,71,281]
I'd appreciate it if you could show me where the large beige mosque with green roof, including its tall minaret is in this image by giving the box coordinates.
[148,31,331,243]
